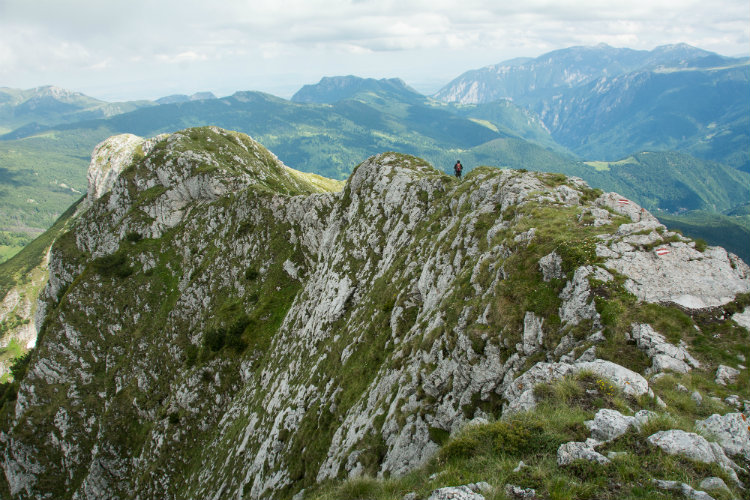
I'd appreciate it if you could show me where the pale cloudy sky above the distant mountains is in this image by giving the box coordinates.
[0,0,750,101]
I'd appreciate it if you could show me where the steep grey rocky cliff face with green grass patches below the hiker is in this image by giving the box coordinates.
[0,128,750,499]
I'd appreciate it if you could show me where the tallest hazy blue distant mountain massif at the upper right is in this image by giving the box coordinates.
[434,44,750,172]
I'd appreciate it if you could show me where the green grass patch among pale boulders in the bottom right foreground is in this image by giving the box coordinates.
[306,374,742,500]
